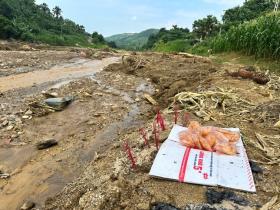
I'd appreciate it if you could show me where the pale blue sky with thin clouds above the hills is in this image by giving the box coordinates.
[36,0,244,37]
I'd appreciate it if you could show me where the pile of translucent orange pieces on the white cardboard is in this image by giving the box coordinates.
[179,121,240,155]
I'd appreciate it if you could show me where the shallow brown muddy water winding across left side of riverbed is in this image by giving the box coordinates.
[0,57,153,210]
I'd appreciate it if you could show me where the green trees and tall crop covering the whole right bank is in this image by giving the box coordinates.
[141,0,280,60]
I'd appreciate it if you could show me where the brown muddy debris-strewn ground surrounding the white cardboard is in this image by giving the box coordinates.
[0,44,280,210]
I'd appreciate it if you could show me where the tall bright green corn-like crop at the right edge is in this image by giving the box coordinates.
[211,12,280,59]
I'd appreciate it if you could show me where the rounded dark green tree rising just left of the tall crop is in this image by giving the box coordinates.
[193,15,220,39]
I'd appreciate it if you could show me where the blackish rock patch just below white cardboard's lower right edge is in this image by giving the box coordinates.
[206,189,249,206]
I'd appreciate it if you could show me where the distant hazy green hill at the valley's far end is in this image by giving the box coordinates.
[105,29,159,50]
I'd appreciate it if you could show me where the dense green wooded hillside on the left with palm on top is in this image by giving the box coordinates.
[0,0,104,46]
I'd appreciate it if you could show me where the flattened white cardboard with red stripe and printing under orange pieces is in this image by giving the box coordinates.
[150,125,256,192]
